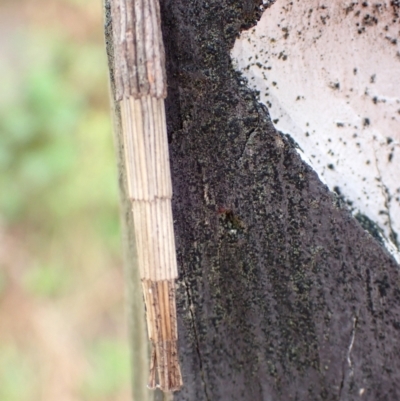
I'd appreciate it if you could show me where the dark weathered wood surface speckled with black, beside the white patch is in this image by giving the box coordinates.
[104,0,400,401]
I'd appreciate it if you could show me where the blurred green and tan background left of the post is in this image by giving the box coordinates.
[0,0,130,401]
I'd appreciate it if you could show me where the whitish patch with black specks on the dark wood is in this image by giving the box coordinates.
[232,0,400,261]
